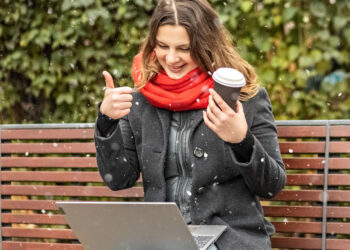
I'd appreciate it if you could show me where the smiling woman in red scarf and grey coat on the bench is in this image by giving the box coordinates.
[95,0,286,249]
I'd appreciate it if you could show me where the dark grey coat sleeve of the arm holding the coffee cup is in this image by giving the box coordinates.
[227,88,286,198]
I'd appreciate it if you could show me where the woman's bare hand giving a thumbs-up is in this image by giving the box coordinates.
[100,71,133,119]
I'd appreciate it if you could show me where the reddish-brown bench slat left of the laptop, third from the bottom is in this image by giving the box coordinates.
[1,213,68,225]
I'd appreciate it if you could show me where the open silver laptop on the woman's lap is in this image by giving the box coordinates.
[56,201,226,250]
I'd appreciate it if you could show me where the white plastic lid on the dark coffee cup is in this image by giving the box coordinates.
[212,68,246,87]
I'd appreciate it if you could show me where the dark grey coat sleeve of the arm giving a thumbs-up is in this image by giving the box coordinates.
[94,113,140,190]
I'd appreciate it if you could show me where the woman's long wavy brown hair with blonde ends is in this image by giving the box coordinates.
[139,0,259,101]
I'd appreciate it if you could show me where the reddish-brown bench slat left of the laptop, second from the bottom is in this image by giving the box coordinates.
[2,227,77,240]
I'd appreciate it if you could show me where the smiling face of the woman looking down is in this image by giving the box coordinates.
[154,25,198,79]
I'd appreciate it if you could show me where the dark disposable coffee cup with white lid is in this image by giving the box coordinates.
[212,68,246,111]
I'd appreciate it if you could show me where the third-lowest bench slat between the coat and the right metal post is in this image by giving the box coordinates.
[263,206,322,218]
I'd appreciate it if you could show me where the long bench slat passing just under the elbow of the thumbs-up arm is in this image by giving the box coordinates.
[2,185,143,198]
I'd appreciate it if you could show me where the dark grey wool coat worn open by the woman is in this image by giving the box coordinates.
[95,88,286,250]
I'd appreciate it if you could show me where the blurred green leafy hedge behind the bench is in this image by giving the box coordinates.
[0,0,350,123]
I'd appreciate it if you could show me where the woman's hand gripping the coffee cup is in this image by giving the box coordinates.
[203,89,248,143]
